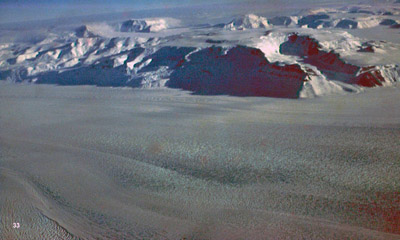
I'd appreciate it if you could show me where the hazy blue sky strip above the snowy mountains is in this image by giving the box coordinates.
[0,0,387,23]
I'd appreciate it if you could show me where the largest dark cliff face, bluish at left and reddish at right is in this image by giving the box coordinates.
[167,46,307,98]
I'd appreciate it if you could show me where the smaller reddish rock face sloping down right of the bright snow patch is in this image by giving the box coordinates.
[280,34,385,87]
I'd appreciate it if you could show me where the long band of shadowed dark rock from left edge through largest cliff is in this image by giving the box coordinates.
[0,44,308,98]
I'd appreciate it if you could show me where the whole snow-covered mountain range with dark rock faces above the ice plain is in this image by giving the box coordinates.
[0,4,400,98]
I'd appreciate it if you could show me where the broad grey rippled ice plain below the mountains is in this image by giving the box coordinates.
[0,83,400,239]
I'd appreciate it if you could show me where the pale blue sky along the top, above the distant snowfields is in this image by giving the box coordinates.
[0,0,385,23]
